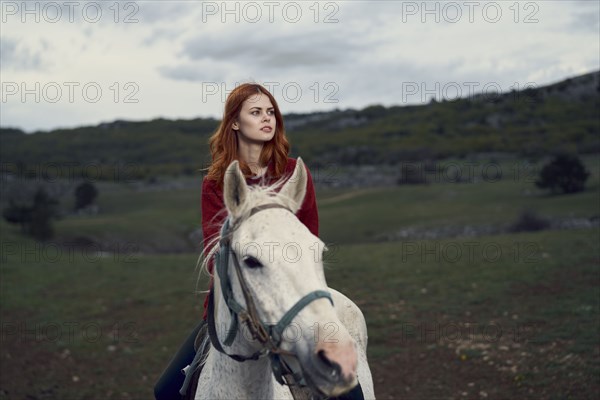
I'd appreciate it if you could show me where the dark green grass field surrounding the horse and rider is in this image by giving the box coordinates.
[0,157,600,399]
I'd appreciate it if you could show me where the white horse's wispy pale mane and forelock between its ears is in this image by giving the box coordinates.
[196,176,293,293]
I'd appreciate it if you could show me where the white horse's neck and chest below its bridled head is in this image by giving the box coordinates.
[198,280,287,399]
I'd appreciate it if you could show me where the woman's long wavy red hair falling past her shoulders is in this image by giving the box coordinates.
[207,83,290,187]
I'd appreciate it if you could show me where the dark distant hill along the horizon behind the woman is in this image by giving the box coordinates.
[0,71,600,178]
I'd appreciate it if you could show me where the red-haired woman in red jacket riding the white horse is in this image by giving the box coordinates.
[154,83,362,400]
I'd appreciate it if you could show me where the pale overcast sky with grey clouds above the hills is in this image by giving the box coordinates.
[0,0,600,132]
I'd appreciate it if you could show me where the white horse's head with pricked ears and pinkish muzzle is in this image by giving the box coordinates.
[215,158,357,396]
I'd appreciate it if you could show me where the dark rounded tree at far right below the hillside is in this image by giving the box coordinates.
[535,153,590,193]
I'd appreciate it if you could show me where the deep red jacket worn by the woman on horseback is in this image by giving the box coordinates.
[202,158,319,319]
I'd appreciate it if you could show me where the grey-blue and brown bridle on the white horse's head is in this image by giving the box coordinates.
[208,203,333,398]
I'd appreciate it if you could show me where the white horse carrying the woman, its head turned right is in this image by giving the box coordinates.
[195,158,375,400]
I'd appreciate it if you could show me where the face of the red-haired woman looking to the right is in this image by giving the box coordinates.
[232,93,277,144]
